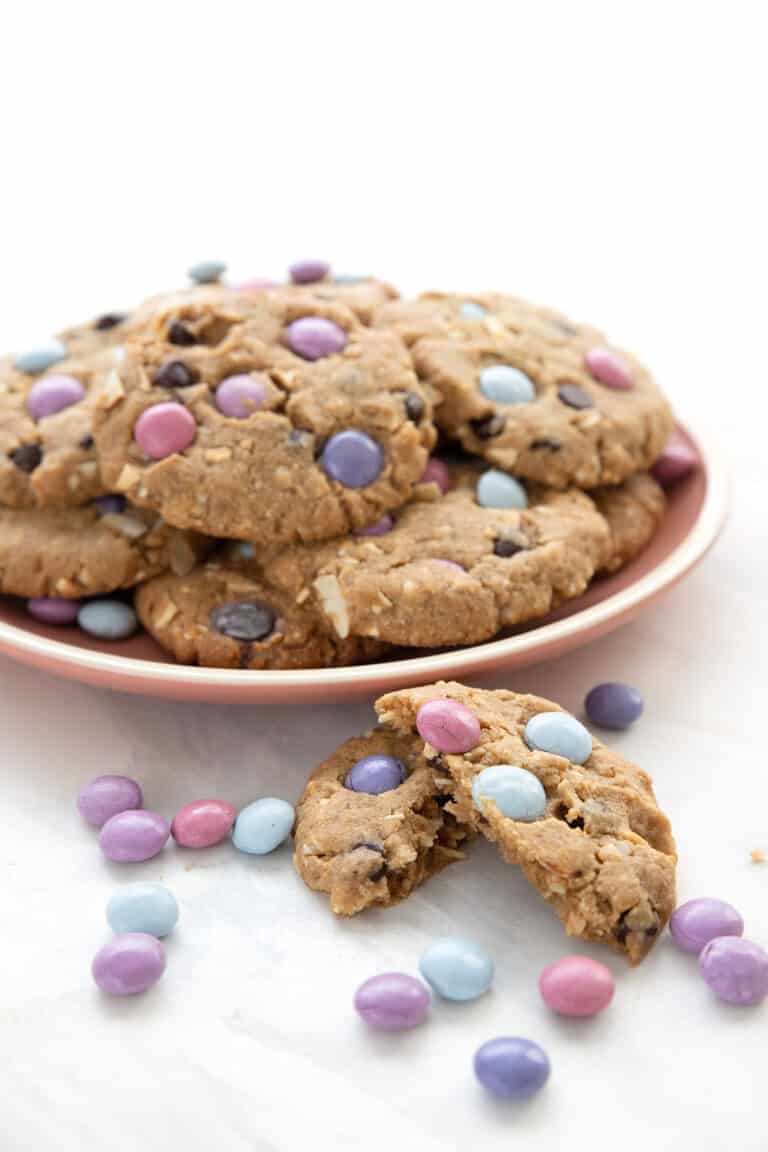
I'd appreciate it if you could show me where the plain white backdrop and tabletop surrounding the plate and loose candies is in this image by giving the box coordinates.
[0,0,768,1152]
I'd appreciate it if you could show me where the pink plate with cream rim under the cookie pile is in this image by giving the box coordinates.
[0,434,727,704]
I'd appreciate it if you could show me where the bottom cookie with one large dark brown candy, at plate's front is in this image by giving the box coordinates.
[136,550,385,669]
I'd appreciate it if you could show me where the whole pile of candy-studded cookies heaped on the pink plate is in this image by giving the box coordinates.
[0,262,690,668]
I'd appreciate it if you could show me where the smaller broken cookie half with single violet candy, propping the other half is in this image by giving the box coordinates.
[294,729,471,916]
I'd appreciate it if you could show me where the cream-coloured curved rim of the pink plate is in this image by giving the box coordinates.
[0,420,729,703]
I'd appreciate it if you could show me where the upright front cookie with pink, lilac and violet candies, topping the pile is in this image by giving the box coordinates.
[94,289,435,546]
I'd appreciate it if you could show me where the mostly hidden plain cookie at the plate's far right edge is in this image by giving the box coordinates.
[590,472,667,573]
